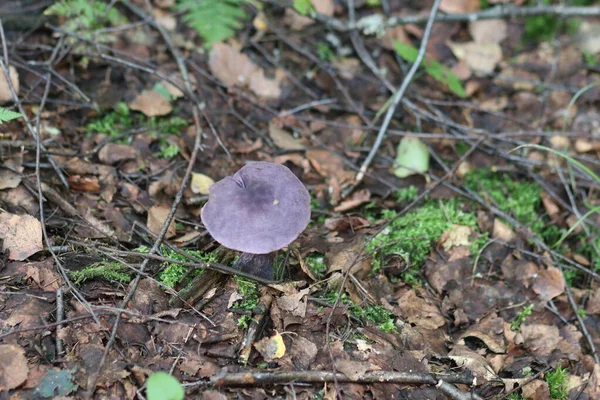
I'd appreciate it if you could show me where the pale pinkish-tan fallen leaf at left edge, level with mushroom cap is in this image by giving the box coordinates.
[0,212,44,261]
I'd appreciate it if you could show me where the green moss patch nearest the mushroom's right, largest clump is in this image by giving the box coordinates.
[367,198,477,274]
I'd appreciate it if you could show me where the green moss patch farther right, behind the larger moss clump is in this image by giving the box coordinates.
[465,169,545,235]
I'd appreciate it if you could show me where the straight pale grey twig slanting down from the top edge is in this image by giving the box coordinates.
[355,0,441,183]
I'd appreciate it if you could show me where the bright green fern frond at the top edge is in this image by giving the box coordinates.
[175,0,248,47]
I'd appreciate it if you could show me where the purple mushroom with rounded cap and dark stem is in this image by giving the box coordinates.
[201,162,310,279]
